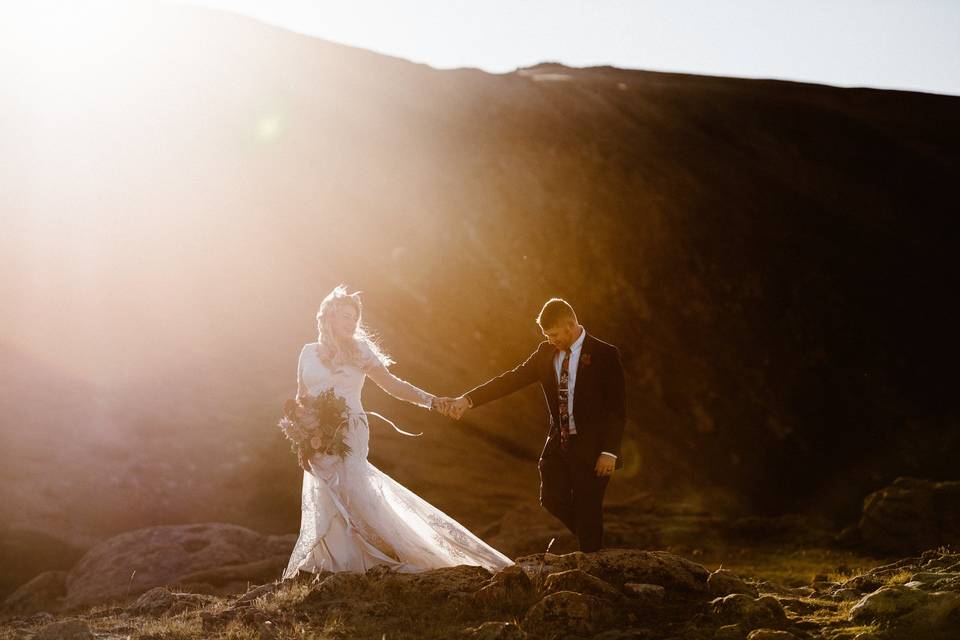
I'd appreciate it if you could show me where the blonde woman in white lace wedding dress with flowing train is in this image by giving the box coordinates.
[283,286,513,578]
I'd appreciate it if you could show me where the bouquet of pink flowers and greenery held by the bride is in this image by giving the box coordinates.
[278,389,350,469]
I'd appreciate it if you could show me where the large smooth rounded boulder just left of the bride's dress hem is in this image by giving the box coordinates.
[64,523,295,609]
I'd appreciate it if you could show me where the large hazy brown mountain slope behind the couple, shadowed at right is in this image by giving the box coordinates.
[0,2,960,548]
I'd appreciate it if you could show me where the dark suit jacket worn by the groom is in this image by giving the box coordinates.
[464,333,626,468]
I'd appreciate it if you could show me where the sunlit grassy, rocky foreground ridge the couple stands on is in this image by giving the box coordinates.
[0,548,960,640]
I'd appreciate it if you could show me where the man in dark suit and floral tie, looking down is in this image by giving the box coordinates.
[441,298,626,552]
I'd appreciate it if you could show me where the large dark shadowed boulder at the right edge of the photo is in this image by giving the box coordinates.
[859,478,960,554]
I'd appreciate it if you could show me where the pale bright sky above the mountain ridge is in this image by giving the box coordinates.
[188,0,960,95]
